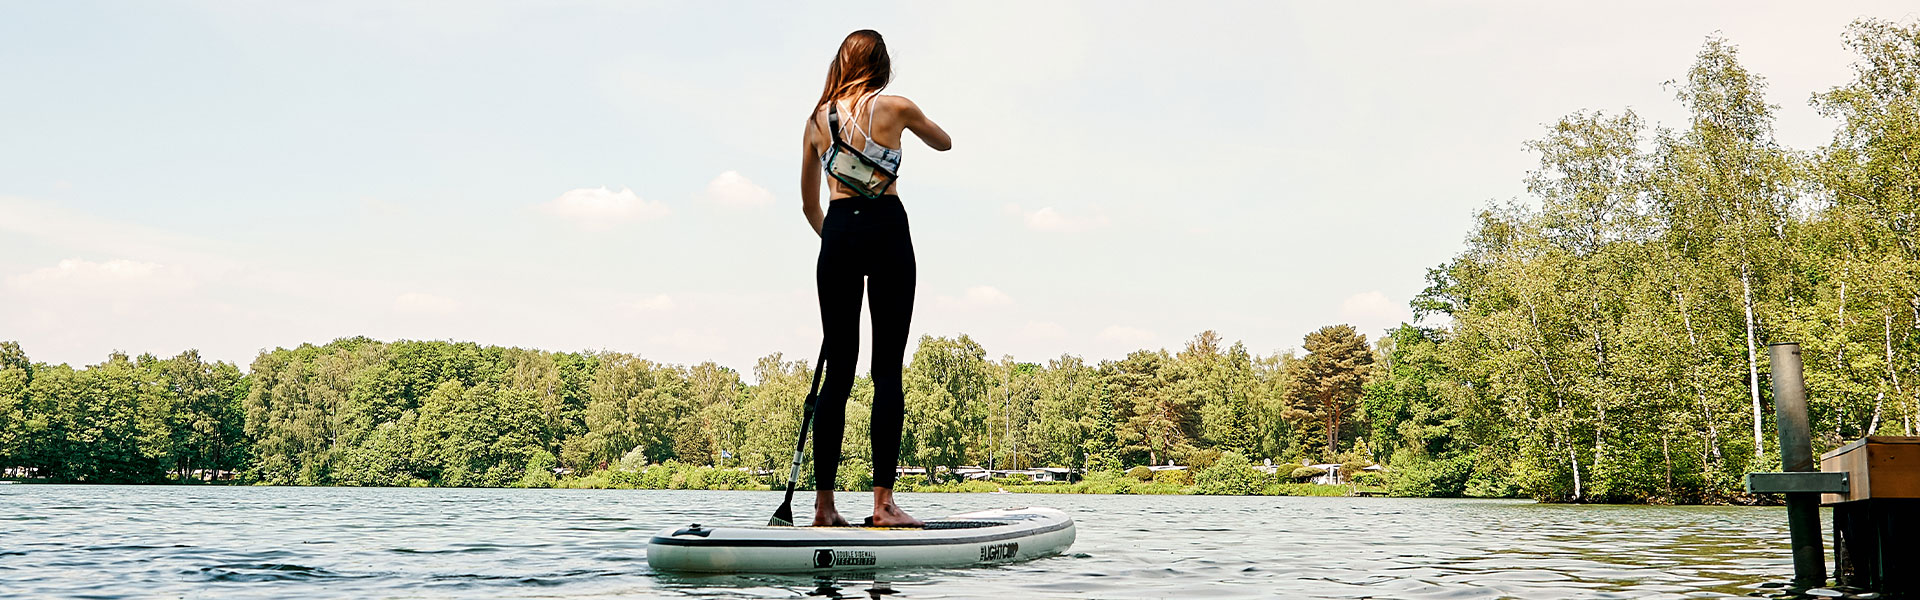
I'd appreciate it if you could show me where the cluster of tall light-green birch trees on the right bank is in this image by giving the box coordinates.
[1367,19,1920,502]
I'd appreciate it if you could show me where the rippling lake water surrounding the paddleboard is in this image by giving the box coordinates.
[0,485,1793,598]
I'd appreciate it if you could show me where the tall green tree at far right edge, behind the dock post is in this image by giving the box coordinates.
[1809,19,1920,435]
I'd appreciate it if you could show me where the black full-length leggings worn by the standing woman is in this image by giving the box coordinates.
[814,194,914,490]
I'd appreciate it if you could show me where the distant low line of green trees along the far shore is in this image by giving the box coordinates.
[0,325,1373,487]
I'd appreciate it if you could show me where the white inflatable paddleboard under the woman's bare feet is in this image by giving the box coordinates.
[647,508,1073,573]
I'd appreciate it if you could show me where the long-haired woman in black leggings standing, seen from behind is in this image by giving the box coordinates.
[801,29,952,527]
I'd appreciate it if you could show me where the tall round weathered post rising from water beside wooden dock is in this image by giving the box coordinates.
[1766,342,1826,587]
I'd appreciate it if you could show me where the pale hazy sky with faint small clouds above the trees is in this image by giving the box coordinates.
[0,0,1920,373]
